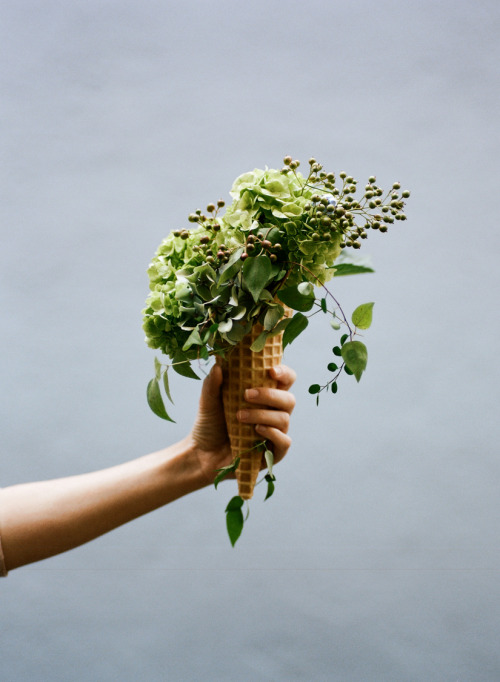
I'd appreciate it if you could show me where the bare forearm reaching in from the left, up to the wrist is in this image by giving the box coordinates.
[0,439,206,569]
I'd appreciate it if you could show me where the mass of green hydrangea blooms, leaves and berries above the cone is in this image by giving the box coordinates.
[143,157,409,376]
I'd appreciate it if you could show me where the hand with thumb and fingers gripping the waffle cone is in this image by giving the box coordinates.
[191,365,296,484]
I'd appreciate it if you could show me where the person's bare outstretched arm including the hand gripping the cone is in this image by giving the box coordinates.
[0,365,295,570]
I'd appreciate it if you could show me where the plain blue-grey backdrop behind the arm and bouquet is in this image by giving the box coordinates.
[0,0,500,682]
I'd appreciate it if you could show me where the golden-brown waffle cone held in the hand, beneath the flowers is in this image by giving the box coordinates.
[216,308,292,500]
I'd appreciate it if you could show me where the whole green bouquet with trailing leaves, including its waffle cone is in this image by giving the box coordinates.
[143,156,410,544]
